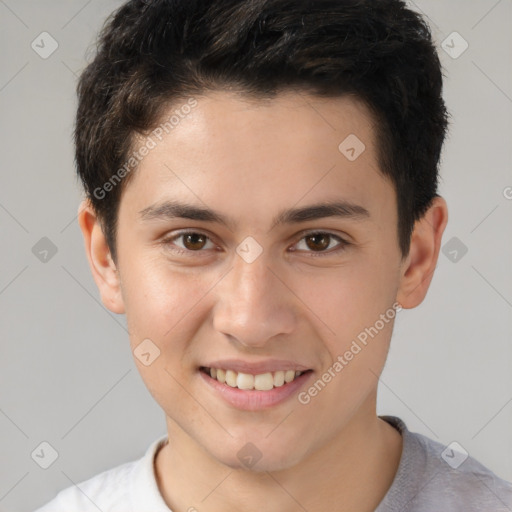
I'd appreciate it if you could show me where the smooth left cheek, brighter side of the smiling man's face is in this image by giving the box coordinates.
[122,258,212,408]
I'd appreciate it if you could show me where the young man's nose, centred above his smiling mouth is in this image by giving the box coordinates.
[213,255,296,348]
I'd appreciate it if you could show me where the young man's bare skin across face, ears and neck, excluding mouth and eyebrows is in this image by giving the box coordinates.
[79,92,448,512]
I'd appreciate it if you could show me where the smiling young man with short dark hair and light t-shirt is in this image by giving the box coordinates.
[34,0,512,512]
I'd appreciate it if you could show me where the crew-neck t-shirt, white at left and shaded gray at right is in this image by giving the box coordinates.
[35,416,512,512]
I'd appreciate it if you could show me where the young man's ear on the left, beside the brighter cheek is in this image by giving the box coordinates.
[78,199,125,313]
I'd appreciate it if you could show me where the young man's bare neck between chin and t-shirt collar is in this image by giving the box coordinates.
[155,400,402,512]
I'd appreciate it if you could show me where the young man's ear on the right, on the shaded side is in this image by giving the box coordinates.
[397,196,448,309]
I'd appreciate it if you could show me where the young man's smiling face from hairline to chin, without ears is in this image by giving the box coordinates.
[106,92,410,470]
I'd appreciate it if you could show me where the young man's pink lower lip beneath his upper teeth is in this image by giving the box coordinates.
[199,371,313,411]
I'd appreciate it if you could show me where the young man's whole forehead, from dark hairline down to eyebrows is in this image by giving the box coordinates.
[122,92,394,228]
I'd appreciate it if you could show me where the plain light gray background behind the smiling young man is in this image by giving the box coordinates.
[0,0,512,512]
